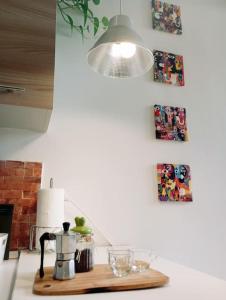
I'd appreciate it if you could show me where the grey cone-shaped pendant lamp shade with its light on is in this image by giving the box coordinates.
[88,15,154,78]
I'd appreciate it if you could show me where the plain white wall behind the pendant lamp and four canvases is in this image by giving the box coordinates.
[0,0,226,279]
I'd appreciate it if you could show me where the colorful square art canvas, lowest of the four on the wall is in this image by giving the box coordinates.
[157,164,192,202]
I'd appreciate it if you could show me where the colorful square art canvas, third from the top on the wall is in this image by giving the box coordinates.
[154,104,188,142]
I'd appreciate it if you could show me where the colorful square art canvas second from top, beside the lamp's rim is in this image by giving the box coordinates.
[153,50,184,86]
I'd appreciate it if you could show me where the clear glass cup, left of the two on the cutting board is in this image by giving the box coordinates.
[108,249,133,277]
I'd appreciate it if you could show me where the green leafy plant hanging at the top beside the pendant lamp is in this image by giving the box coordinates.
[57,0,109,38]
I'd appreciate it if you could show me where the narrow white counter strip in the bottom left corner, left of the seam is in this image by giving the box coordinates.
[0,259,18,300]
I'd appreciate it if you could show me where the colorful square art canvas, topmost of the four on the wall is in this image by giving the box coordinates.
[152,0,182,34]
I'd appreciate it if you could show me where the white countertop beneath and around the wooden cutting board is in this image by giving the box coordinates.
[11,248,226,300]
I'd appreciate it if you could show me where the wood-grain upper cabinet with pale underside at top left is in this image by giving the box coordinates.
[0,0,56,131]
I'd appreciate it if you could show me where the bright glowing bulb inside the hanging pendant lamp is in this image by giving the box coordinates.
[111,42,136,58]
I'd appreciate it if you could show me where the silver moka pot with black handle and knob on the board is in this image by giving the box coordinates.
[39,222,78,280]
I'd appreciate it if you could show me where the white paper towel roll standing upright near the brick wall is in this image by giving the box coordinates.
[36,188,64,227]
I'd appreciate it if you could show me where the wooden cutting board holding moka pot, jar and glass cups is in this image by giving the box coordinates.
[33,264,169,295]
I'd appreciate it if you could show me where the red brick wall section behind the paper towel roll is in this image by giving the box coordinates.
[0,160,42,250]
